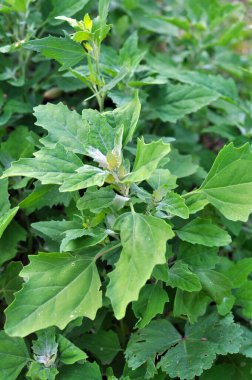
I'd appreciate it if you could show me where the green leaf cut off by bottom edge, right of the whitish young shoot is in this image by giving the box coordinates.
[60,362,102,380]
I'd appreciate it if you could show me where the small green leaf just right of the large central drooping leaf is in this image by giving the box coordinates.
[168,260,202,292]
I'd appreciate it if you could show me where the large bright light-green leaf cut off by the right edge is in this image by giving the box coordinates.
[200,143,252,222]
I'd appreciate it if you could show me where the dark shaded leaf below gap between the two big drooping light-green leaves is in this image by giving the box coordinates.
[78,329,121,364]
